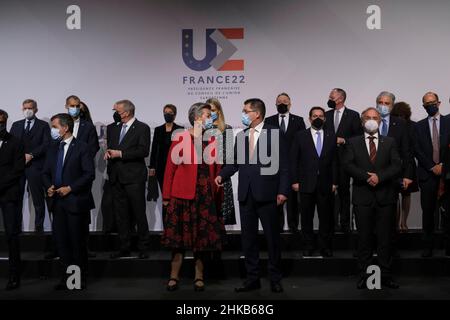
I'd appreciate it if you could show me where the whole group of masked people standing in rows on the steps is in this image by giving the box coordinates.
[0,88,450,292]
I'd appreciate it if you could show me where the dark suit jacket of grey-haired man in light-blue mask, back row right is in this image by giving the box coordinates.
[388,116,415,180]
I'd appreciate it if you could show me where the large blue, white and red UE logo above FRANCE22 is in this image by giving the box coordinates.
[182,28,244,71]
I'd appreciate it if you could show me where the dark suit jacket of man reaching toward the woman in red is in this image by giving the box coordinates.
[219,123,290,202]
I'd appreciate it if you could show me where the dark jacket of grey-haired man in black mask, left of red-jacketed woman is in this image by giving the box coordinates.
[106,119,150,184]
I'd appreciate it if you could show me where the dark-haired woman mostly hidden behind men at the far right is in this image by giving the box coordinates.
[391,102,419,232]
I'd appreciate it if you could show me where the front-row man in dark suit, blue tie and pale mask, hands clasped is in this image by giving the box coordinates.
[43,113,95,290]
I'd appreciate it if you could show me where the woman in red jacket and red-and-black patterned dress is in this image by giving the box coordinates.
[161,103,225,291]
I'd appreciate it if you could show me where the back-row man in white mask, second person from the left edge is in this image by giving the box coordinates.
[10,99,51,232]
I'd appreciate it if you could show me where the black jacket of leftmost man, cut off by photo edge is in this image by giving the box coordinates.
[0,133,25,202]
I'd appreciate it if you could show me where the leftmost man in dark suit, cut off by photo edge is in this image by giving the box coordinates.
[0,110,25,290]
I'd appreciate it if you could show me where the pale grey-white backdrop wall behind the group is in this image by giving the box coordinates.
[0,0,450,230]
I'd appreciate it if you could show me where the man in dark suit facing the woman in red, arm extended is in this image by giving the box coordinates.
[215,99,290,292]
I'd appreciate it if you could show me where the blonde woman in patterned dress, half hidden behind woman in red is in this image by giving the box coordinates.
[206,98,236,225]
